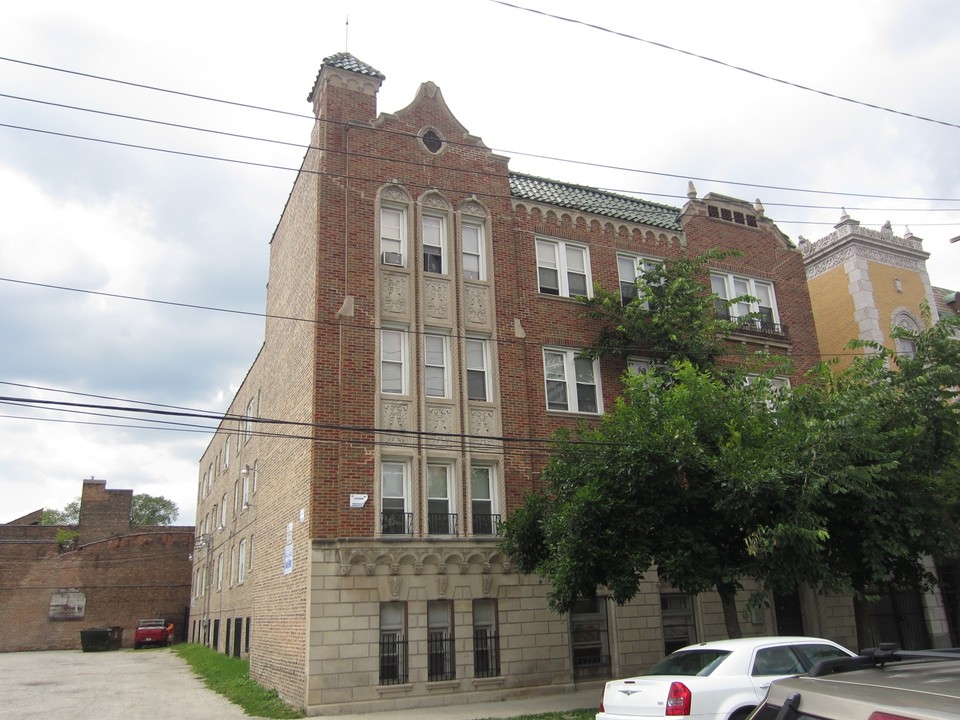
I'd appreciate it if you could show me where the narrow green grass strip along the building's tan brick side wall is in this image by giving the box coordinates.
[173,643,303,719]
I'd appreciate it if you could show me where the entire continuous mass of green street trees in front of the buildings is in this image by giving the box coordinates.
[502,253,960,636]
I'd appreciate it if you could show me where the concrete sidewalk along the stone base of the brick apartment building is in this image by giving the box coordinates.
[322,684,603,720]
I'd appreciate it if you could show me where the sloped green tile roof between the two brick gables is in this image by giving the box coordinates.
[510,172,682,232]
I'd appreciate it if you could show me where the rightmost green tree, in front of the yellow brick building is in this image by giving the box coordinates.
[751,308,960,646]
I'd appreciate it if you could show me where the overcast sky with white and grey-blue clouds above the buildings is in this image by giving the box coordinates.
[0,0,960,524]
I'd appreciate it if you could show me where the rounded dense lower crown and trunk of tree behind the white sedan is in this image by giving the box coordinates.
[503,361,790,637]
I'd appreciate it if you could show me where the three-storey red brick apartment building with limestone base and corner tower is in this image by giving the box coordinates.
[190,53,855,714]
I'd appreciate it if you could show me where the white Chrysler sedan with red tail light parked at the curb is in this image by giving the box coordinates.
[596,637,855,720]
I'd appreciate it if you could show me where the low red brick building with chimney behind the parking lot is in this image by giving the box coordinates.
[0,479,194,652]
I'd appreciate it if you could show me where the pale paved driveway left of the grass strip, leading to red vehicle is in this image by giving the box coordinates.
[0,649,249,720]
